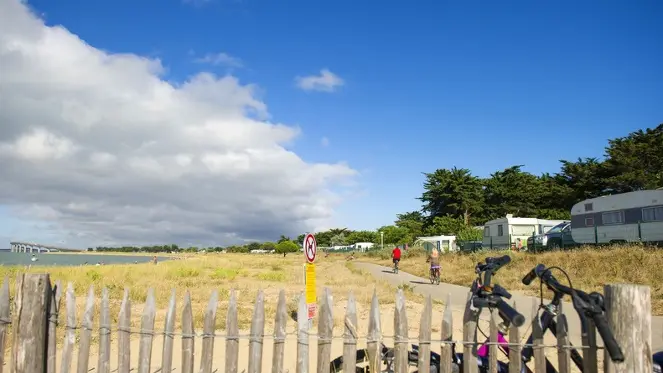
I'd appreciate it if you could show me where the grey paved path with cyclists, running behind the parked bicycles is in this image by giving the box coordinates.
[355,262,663,351]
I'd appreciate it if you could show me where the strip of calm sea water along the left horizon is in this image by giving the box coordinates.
[0,251,170,267]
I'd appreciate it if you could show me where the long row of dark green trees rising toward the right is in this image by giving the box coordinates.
[93,123,663,252]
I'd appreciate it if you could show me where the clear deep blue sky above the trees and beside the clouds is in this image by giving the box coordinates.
[1,0,663,246]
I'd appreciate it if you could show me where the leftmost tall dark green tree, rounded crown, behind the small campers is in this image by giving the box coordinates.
[419,167,483,225]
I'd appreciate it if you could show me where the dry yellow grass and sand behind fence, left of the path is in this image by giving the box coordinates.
[0,253,422,348]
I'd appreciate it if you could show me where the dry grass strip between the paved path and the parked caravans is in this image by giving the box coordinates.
[361,246,663,316]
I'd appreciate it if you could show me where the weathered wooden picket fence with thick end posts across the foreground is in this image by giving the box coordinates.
[0,274,652,373]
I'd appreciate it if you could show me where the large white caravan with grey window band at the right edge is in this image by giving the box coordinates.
[571,189,663,244]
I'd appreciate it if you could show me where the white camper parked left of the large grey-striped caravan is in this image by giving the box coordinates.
[483,214,564,249]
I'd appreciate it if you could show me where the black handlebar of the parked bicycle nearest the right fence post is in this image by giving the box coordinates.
[522,264,624,362]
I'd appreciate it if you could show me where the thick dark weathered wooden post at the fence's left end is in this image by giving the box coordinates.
[10,273,52,373]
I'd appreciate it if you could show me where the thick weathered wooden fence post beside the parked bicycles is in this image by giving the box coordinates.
[604,284,653,373]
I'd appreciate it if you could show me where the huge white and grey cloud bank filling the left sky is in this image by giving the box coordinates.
[0,0,356,246]
